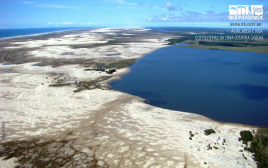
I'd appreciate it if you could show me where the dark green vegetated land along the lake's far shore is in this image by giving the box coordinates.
[163,29,268,53]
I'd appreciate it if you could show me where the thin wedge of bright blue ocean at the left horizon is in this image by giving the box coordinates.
[0,27,84,39]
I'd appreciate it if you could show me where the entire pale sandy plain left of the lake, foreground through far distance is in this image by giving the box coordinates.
[0,28,256,167]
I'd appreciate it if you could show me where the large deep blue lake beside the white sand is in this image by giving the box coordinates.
[110,46,268,126]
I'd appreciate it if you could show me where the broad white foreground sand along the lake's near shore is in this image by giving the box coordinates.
[0,67,256,167]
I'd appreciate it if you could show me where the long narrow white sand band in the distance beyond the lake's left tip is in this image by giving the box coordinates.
[30,39,166,59]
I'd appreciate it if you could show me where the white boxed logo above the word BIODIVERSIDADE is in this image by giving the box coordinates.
[228,5,263,20]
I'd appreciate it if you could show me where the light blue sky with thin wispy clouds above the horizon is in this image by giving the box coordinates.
[0,0,268,29]
